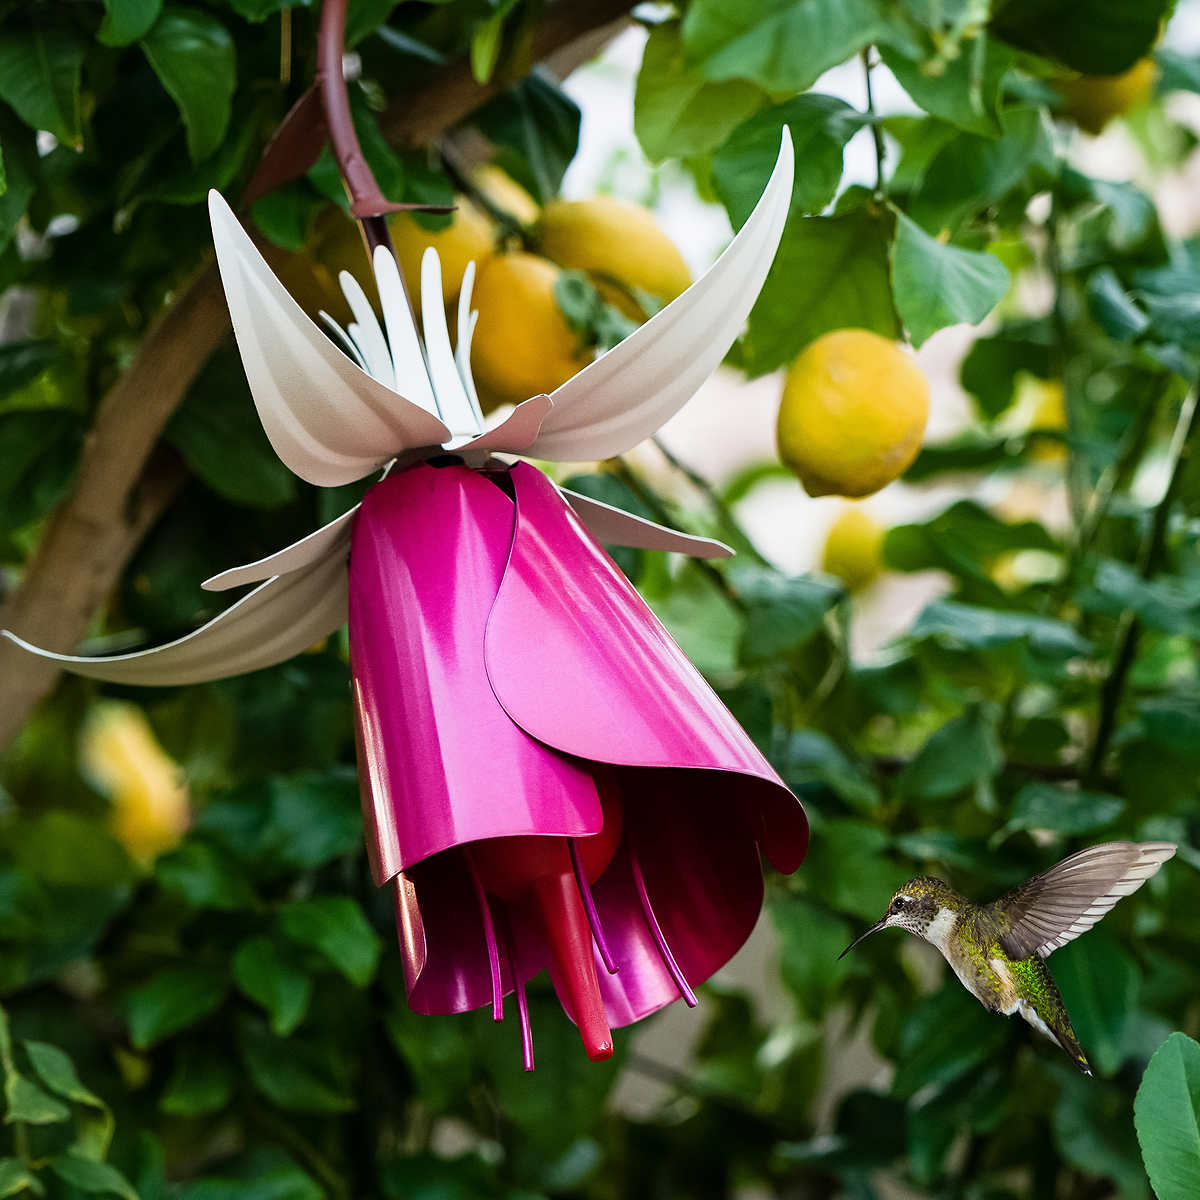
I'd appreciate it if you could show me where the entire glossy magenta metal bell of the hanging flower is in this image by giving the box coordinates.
[350,464,808,1032]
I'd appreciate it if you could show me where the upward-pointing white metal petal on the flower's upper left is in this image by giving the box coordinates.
[209,192,450,486]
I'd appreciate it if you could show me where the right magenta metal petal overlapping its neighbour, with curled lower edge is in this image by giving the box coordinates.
[480,463,808,873]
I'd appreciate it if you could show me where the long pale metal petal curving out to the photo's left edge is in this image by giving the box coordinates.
[0,556,347,686]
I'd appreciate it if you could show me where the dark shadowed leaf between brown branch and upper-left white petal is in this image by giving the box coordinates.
[164,349,296,509]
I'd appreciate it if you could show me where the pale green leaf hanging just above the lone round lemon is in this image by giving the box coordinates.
[892,214,1012,346]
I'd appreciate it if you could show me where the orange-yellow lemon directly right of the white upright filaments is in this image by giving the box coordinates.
[470,253,592,404]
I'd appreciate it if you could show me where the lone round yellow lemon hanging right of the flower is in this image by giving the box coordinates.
[776,329,929,497]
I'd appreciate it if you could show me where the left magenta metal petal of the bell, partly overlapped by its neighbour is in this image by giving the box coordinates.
[349,464,604,893]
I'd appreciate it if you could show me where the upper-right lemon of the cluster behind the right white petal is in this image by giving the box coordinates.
[534,196,691,320]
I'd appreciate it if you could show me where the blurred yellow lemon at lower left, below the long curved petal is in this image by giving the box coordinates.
[79,702,191,864]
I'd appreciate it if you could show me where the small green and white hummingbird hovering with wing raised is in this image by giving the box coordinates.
[838,841,1177,1075]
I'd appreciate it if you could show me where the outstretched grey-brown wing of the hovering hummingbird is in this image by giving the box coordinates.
[988,841,1176,959]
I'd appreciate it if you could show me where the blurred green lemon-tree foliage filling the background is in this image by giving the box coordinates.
[0,0,1200,1200]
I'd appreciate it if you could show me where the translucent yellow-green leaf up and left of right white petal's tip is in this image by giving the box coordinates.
[634,24,763,162]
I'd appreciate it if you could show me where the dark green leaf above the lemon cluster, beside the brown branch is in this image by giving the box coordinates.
[473,71,581,204]
